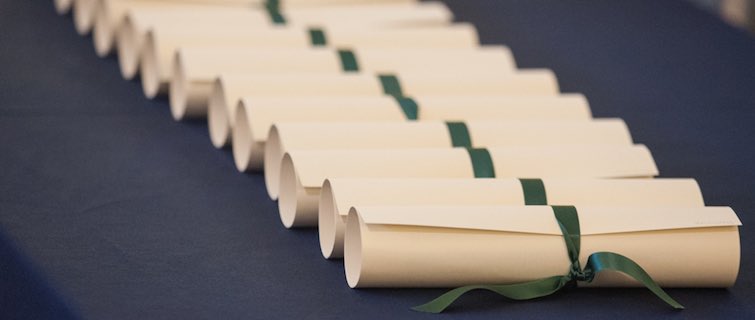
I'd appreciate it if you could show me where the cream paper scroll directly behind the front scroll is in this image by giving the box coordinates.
[318,178,705,259]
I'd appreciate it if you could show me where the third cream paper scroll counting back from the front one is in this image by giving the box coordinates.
[276,145,658,228]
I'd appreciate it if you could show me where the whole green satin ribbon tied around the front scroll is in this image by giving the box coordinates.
[412,206,684,313]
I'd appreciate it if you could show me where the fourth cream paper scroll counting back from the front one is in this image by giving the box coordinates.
[263,119,632,200]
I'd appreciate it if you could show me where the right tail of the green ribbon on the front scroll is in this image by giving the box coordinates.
[585,252,684,310]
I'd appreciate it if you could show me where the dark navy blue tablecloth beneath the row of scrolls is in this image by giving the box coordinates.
[0,0,755,319]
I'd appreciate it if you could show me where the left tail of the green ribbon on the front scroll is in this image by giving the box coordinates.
[412,276,568,313]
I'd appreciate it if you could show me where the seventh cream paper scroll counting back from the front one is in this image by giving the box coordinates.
[170,46,515,120]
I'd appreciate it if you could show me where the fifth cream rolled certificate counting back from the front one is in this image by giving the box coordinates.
[233,93,580,172]
